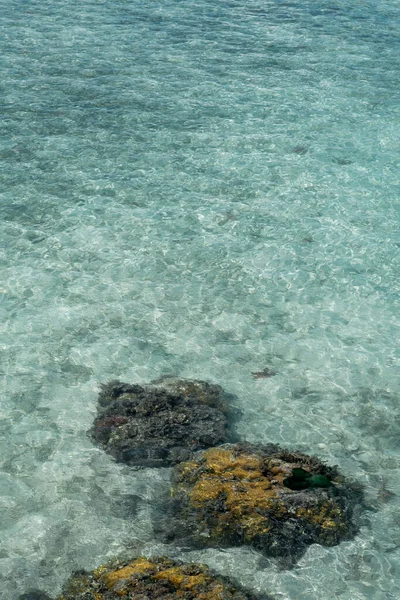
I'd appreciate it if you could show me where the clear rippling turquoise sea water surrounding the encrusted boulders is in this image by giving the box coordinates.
[0,0,400,600]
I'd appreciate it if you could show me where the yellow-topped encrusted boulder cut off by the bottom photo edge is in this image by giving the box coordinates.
[57,557,270,600]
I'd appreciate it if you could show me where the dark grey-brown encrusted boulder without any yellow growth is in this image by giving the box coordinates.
[89,377,233,467]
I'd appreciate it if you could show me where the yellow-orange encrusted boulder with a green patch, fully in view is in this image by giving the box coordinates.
[166,444,361,559]
